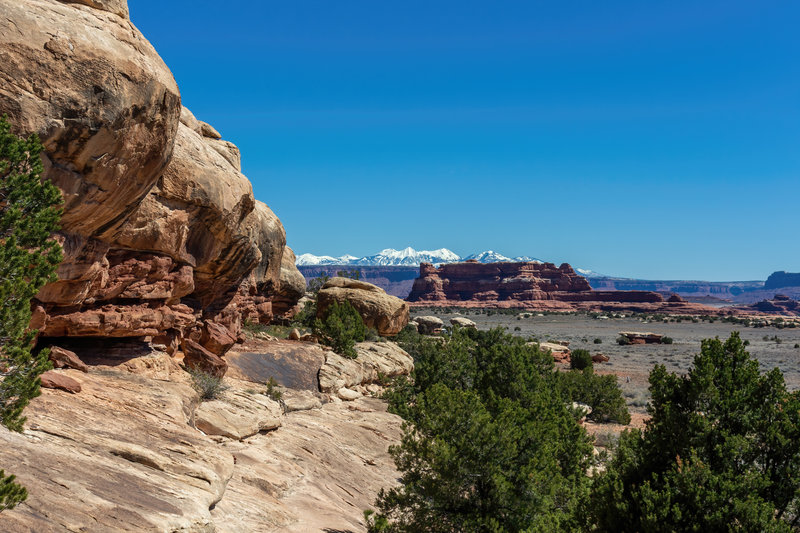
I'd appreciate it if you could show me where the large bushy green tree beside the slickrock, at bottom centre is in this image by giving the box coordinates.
[368,328,592,532]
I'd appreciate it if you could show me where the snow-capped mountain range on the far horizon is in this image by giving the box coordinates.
[296,246,542,266]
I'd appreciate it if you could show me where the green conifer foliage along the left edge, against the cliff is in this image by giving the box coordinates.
[0,116,61,511]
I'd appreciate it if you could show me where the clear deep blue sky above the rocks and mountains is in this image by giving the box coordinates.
[130,0,800,280]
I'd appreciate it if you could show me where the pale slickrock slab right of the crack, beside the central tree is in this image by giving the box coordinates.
[211,398,402,533]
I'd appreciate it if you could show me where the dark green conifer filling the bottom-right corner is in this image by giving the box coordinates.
[587,333,800,532]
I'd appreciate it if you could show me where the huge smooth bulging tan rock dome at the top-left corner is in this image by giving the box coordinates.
[0,0,180,237]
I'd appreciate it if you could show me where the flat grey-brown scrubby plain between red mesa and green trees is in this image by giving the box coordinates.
[412,308,800,423]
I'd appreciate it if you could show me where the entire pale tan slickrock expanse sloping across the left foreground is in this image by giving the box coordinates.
[0,343,401,533]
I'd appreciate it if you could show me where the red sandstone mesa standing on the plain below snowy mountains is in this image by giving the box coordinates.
[407,262,716,314]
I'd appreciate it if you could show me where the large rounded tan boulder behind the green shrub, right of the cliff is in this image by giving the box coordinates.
[317,277,408,335]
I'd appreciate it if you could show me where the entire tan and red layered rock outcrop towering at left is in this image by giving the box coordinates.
[0,0,304,355]
